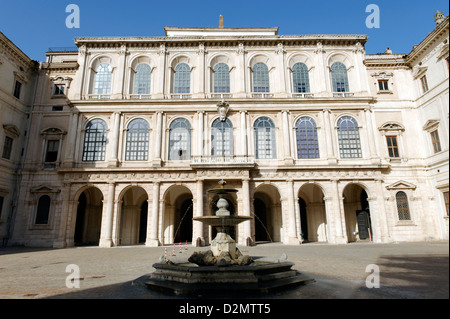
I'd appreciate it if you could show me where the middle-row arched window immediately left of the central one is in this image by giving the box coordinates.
[169,118,191,161]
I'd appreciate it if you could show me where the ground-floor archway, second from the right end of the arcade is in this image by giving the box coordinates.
[298,184,328,242]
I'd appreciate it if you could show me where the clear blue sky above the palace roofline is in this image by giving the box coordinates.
[0,0,449,61]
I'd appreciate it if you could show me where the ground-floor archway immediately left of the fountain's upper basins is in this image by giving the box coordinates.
[163,185,194,245]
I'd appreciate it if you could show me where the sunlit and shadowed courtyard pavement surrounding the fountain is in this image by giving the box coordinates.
[0,241,449,300]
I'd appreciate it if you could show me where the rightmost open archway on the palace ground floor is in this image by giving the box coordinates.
[343,184,373,242]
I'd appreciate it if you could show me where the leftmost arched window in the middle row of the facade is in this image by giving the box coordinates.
[83,119,107,162]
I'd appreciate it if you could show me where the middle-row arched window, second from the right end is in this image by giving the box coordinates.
[295,116,320,159]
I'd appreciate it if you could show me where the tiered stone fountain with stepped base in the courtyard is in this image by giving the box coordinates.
[146,180,314,295]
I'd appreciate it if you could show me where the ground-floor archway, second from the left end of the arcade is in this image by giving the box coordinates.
[119,186,148,245]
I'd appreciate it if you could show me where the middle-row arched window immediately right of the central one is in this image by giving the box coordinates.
[255,117,277,159]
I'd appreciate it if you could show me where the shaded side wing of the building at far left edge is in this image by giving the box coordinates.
[0,32,39,246]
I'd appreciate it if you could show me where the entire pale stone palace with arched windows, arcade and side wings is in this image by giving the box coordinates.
[0,14,449,248]
